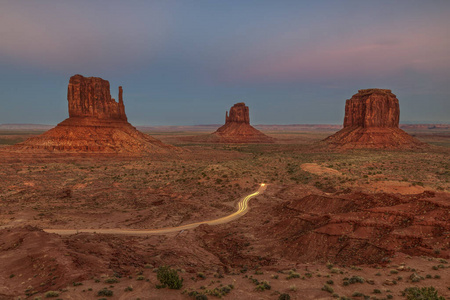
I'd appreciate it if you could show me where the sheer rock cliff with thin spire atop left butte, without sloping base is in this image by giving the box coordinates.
[67,75,127,121]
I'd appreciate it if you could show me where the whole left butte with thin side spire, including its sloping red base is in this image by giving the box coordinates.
[13,75,177,154]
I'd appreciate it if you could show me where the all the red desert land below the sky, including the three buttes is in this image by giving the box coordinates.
[0,75,450,299]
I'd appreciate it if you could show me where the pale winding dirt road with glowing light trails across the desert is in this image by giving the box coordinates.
[43,183,267,235]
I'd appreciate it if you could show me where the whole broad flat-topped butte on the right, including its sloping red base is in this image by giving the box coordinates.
[324,89,426,149]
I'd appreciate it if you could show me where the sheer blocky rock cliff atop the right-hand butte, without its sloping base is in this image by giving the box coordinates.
[344,89,400,128]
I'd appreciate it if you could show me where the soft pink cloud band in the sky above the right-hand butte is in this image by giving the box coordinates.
[224,24,450,81]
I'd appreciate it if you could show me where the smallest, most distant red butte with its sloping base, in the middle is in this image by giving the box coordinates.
[212,102,274,143]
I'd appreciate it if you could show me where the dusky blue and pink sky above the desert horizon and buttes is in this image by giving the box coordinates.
[0,0,450,126]
